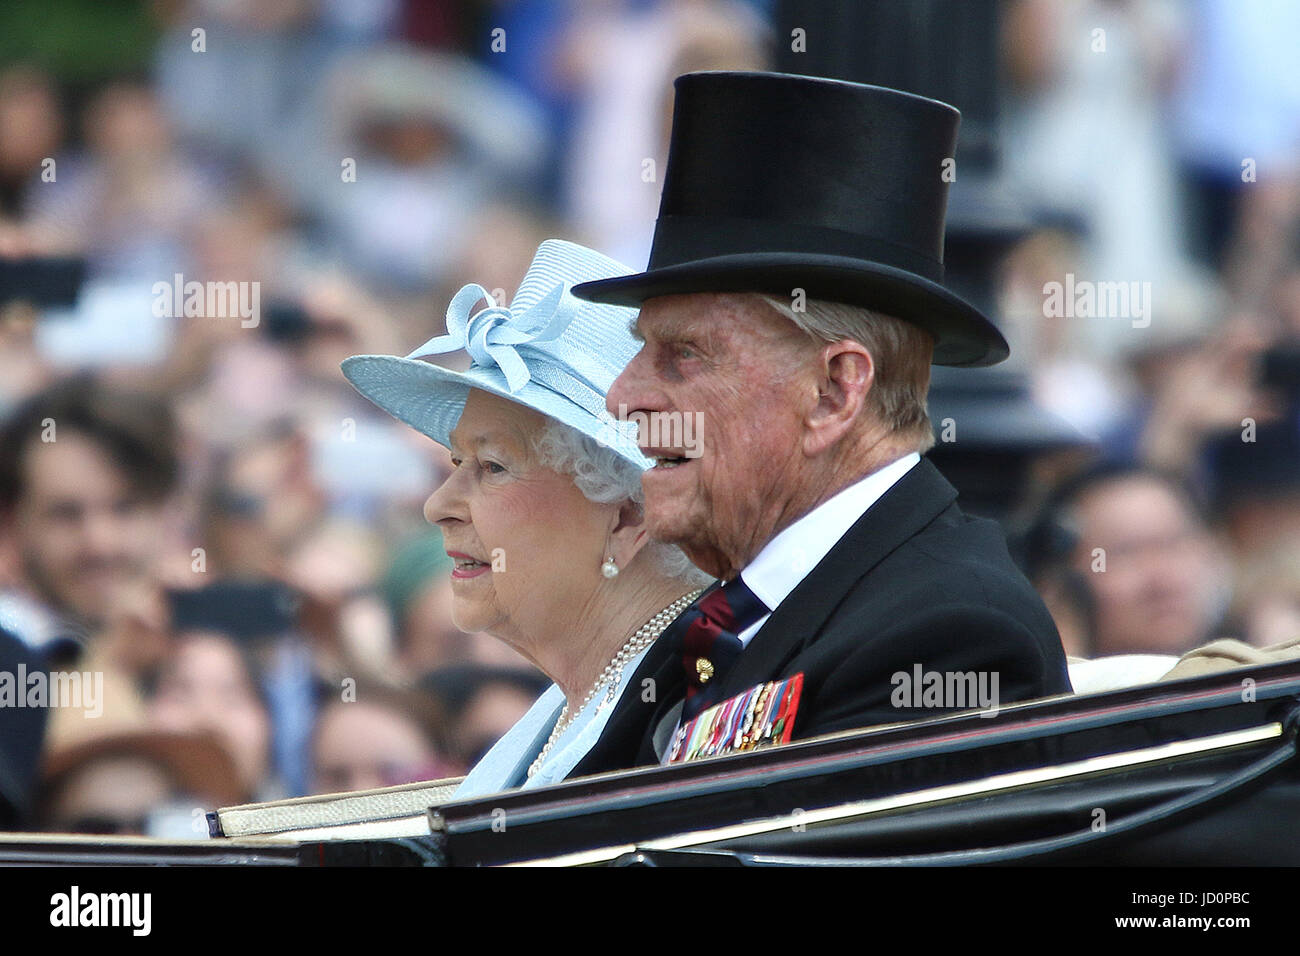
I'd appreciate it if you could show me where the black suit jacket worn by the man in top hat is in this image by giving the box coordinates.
[572,458,1071,777]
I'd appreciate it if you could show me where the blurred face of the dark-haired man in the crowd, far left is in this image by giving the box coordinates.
[13,431,159,626]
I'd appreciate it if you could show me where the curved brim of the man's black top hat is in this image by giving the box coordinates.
[573,252,1010,368]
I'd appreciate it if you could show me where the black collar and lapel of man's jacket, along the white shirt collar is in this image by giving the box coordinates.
[719,458,957,700]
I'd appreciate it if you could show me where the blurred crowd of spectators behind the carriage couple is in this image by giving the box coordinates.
[0,0,1300,836]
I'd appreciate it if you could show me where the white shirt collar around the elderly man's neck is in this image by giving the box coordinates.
[740,451,920,616]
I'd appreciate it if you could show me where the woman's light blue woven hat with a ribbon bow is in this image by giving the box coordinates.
[342,239,651,468]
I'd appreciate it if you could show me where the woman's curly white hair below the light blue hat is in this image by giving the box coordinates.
[534,419,714,588]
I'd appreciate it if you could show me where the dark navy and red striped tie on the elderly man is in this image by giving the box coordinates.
[670,578,768,721]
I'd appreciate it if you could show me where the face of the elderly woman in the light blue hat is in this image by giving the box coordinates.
[424,389,618,657]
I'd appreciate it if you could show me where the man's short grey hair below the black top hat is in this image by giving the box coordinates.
[755,293,935,453]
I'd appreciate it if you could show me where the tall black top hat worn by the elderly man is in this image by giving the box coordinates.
[573,72,1009,365]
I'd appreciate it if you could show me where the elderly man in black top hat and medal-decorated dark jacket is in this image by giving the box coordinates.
[575,73,1070,773]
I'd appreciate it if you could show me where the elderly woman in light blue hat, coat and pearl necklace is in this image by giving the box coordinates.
[343,239,710,797]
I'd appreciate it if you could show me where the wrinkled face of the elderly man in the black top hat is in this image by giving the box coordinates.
[606,294,818,578]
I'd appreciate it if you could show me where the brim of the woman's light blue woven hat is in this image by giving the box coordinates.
[342,355,651,470]
